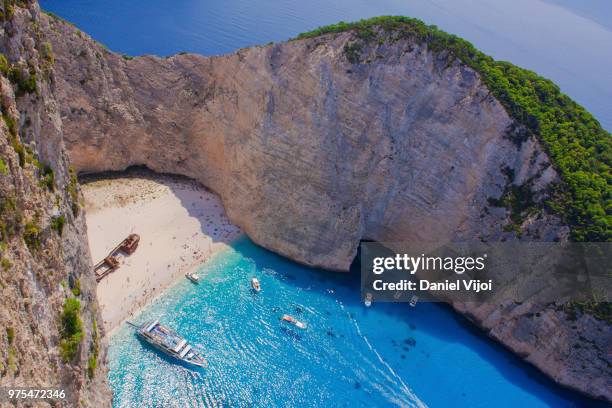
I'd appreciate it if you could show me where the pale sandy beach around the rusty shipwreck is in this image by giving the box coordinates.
[82,172,241,334]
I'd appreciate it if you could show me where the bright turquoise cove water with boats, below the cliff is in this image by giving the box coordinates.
[109,239,584,407]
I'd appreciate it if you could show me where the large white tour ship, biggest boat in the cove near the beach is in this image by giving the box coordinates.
[128,320,208,367]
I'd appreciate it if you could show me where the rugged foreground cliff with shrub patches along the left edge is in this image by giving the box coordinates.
[0,2,111,407]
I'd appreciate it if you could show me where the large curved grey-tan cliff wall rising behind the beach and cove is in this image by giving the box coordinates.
[11,4,612,399]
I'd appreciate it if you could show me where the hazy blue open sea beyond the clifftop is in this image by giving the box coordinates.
[40,0,612,130]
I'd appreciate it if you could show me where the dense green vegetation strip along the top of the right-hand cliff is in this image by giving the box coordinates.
[297,17,612,241]
